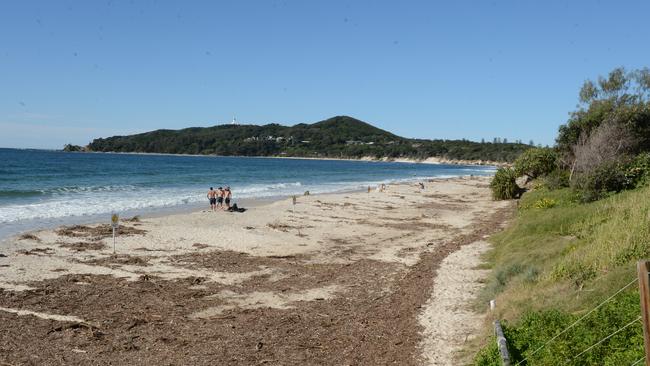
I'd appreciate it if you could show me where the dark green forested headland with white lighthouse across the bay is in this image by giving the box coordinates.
[87,116,529,161]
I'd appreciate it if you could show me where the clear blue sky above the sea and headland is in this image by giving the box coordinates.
[0,0,650,149]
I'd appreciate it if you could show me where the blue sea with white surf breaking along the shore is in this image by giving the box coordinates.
[0,149,494,238]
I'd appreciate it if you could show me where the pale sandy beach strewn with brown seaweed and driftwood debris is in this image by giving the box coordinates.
[0,177,511,365]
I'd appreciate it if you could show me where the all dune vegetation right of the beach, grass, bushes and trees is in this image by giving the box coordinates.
[474,69,650,366]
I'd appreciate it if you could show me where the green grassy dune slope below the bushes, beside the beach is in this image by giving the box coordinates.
[475,187,650,365]
